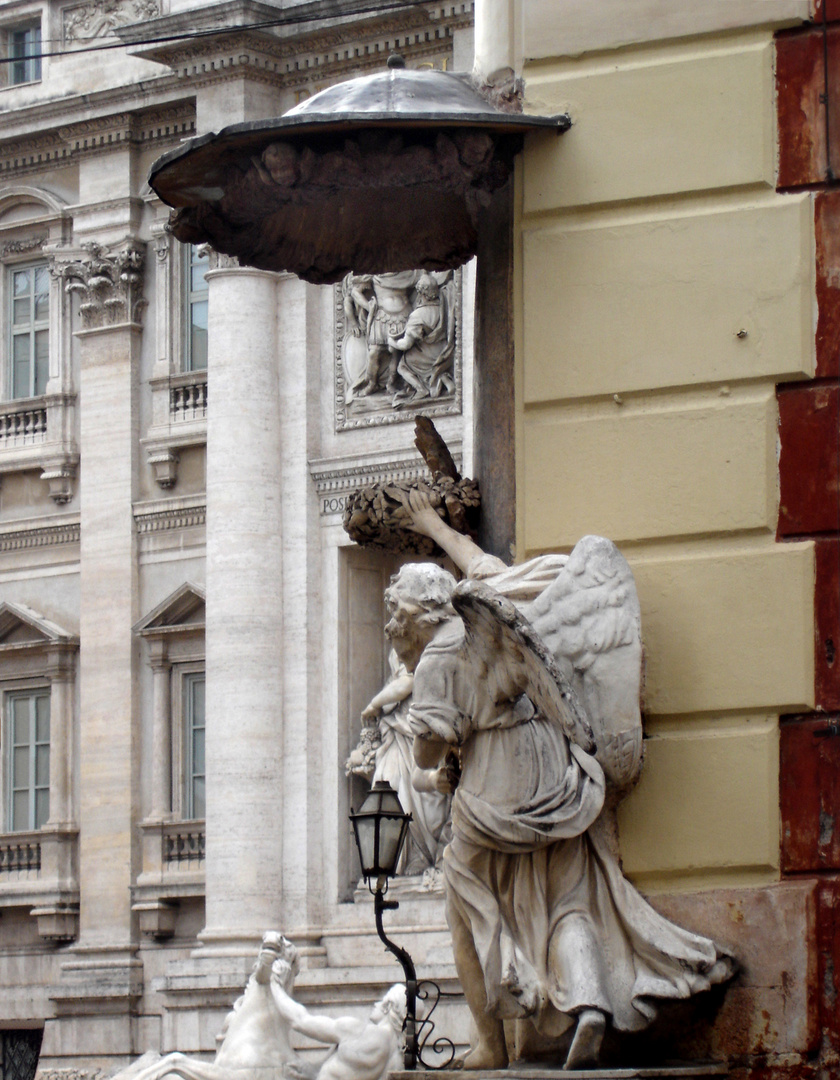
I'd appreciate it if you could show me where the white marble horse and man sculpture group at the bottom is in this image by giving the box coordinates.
[113,931,406,1080]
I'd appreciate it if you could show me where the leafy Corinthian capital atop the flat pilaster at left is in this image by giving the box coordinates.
[61,240,147,329]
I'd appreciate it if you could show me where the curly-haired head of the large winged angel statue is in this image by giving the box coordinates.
[385,563,455,671]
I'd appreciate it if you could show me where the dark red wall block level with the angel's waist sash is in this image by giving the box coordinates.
[780,714,840,874]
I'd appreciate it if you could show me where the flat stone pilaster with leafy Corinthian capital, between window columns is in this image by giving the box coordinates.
[42,240,145,1062]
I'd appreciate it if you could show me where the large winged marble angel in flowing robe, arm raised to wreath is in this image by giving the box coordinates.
[385,489,734,1069]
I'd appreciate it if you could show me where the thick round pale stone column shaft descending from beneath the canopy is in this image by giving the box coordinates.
[200,257,283,953]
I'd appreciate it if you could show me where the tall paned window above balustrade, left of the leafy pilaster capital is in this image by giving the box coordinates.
[9,264,50,397]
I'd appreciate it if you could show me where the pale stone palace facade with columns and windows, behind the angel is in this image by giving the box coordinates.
[0,0,474,1078]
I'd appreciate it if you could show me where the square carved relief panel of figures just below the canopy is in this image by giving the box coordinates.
[341,270,456,408]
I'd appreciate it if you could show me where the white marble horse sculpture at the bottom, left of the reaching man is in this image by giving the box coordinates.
[107,931,308,1080]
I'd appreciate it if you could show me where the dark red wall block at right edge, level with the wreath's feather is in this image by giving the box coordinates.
[777,383,840,538]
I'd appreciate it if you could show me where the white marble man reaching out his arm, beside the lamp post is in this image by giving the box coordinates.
[265,983,406,1080]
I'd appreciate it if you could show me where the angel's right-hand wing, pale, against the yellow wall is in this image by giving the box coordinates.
[521,537,642,788]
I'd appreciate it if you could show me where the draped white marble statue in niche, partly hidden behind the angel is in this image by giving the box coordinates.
[347,649,451,877]
